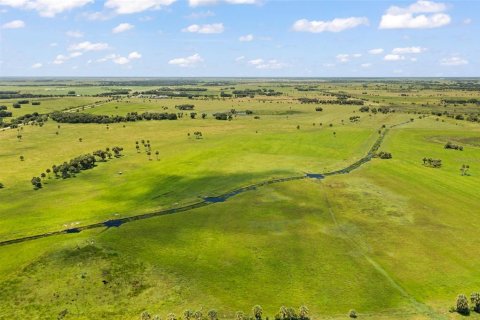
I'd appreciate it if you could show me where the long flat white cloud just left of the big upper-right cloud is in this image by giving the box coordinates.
[292,17,368,33]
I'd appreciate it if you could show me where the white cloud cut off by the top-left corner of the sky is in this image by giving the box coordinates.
[0,0,93,18]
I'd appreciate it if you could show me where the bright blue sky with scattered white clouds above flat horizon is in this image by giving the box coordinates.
[0,0,480,77]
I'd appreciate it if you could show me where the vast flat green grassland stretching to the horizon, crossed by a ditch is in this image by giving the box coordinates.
[0,79,480,319]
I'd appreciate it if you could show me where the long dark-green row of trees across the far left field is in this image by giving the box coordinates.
[50,112,178,123]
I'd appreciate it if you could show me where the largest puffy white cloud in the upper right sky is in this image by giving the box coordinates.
[379,0,451,29]
